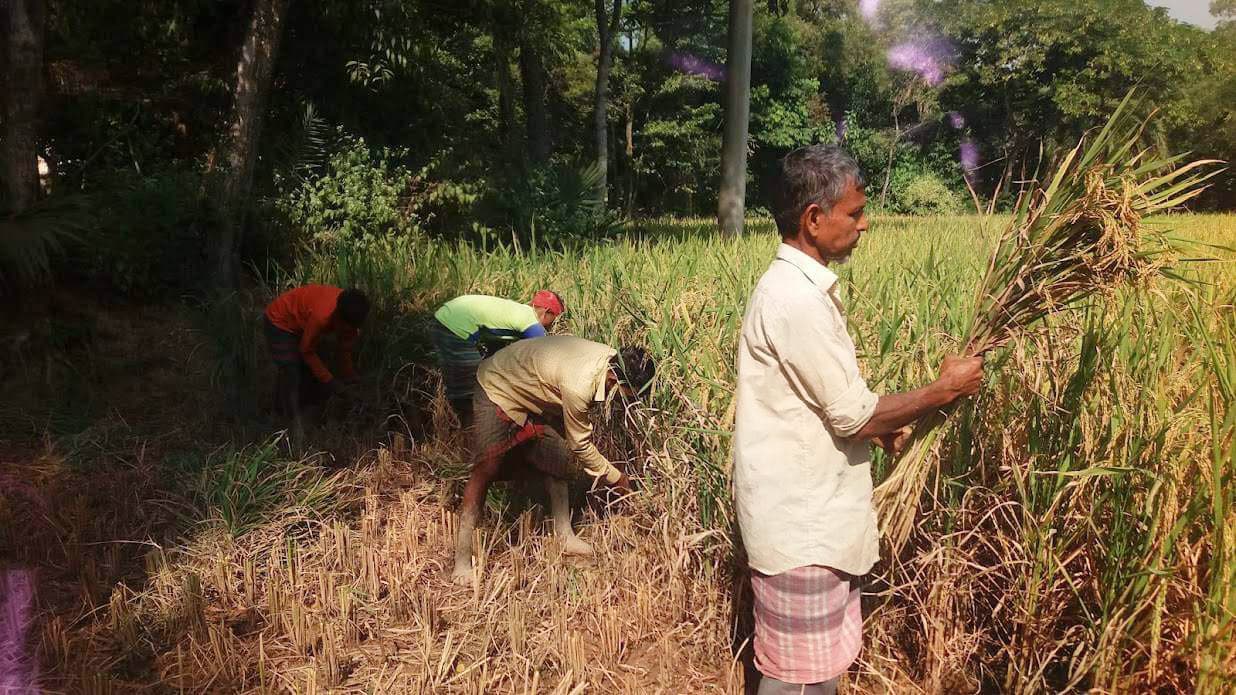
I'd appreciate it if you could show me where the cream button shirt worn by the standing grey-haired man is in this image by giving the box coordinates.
[734,244,879,575]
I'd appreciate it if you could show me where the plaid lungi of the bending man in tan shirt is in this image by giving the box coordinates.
[472,383,580,480]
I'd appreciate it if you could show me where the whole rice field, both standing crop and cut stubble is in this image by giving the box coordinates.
[0,215,1236,694]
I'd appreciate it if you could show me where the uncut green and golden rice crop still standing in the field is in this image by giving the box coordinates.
[284,215,1236,691]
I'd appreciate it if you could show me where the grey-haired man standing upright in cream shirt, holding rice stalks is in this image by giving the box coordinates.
[734,145,983,695]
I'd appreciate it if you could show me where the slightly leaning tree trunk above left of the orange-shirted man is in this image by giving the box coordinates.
[210,0,288,291]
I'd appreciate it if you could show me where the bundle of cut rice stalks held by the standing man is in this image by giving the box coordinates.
[875,92,1221,554]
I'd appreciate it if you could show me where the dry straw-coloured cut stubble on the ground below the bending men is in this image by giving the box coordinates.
[111,441,737,693]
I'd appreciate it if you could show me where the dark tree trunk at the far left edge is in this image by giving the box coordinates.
[0,0,47,213]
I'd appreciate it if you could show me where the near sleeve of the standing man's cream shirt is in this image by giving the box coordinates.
[764,294,880,437]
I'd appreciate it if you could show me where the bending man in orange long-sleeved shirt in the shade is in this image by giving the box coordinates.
[263,284,370,430]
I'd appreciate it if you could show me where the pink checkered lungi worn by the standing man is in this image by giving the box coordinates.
[751,565,863,684]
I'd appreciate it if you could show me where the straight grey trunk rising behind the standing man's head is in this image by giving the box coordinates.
[717,0,751,236]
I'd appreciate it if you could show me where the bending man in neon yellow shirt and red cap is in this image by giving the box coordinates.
[433,289,566,425]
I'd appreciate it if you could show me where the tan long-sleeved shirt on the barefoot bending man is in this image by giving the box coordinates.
[476,335,622,482]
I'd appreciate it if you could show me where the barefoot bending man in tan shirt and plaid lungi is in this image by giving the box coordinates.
[454,335,655,584]
